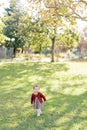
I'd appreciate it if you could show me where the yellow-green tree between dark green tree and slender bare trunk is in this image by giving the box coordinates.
[27,19,49,53]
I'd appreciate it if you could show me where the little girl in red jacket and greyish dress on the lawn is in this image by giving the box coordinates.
[31,85,46,116]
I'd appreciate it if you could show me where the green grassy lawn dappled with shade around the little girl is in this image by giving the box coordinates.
[0,62,87,130]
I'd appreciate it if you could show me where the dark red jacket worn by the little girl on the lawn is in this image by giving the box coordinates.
[31,92,46,104]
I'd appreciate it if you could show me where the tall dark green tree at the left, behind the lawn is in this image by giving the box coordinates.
[4,0,28,57]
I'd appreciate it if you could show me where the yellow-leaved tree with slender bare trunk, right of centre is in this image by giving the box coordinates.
[34,0,82,62]
